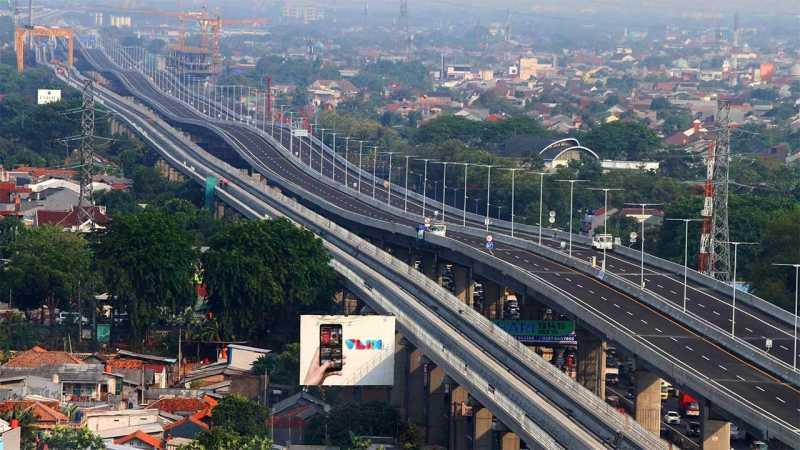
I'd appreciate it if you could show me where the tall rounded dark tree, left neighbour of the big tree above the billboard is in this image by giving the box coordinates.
[95,208,197,342]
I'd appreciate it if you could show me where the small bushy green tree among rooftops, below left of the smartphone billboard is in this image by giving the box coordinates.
[211,394,269,438]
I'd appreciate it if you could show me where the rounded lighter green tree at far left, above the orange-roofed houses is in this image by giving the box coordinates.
[6,225,91,325]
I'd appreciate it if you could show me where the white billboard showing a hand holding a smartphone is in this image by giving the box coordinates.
[300,315,395,386]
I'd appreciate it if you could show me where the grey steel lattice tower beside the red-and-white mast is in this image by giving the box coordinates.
[708,102,731,281]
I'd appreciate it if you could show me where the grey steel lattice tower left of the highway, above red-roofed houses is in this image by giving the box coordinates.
[78,80,95,230]
